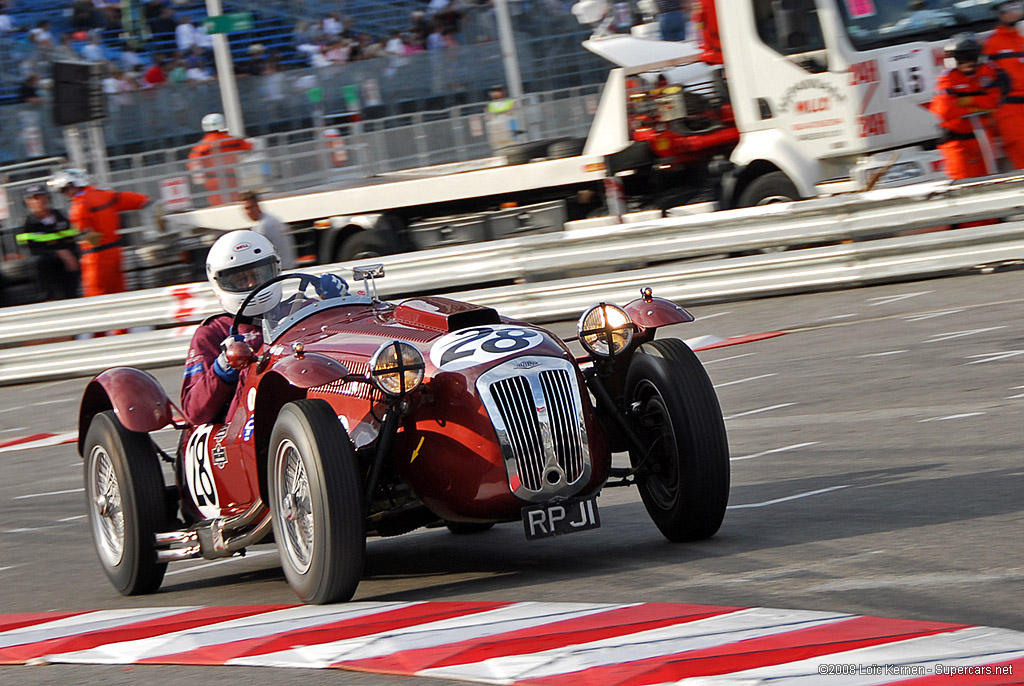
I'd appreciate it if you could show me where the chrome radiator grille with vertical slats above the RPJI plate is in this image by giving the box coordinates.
[477,357,590,500]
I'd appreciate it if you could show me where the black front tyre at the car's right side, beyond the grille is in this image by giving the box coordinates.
[626,339,729,542]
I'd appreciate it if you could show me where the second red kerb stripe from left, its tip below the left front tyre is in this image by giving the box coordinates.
[0,605,292,664]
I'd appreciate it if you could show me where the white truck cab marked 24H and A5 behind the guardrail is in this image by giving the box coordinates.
[578,0,994,206]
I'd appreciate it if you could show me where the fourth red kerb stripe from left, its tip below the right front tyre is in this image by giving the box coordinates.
[339,603,742,684]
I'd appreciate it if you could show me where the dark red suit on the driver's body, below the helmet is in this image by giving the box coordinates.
[181,314,263,424]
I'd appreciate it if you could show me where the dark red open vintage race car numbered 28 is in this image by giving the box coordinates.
[79,266,729,603]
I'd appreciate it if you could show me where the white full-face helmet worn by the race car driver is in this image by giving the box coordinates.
[206,229,282,316]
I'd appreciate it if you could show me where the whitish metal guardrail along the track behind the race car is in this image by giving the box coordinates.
[0,176,1024,385]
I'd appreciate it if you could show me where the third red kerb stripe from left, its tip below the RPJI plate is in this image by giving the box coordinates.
[136,602,512,664]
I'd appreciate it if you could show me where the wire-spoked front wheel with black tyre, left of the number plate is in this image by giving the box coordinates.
[268,399,367,605]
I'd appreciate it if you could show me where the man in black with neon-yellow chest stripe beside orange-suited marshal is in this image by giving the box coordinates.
[17,183,81,300]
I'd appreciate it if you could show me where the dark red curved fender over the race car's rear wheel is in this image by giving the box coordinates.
[78,367,174,455]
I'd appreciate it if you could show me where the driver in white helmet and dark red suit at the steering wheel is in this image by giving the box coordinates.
[181,230,282,424]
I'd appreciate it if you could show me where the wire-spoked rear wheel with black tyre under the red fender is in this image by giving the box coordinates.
[84,411,169,596]
